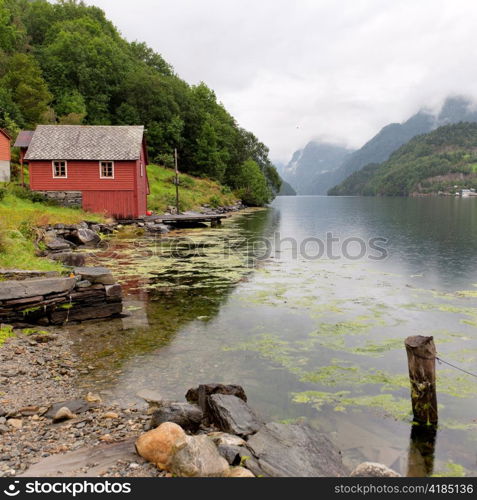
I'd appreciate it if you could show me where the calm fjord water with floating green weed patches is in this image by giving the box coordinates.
[69,197,477,475]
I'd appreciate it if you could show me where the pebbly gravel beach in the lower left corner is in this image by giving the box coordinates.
[0,328,163,477]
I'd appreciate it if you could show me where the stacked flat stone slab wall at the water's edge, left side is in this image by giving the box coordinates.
[0,267,122,325]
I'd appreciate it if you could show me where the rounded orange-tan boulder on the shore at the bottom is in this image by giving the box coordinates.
[136,422,187,469]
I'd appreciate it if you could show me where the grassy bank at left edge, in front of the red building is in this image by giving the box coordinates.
[0,185,104,271]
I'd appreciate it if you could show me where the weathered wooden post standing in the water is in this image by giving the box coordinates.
[404,335,437,424]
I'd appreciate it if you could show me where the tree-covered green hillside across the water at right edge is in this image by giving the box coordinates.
[328,122,477,196]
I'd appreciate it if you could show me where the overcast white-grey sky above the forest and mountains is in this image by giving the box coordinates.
[87,0,477,161]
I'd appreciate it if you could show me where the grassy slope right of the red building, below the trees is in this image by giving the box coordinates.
[147,165,237,212]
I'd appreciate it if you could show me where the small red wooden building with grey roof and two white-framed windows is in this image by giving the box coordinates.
[15,125,149,219]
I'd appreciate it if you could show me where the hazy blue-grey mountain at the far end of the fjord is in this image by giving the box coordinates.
[281,141,352,194]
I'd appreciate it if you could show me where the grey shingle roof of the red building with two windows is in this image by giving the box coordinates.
[25,125,144,160]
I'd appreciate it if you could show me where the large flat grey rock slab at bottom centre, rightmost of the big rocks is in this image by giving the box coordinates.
[245,423,348,477]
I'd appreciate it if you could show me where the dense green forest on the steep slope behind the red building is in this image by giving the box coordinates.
[0,0,281,205]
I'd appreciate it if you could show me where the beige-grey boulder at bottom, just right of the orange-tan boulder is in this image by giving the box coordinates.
[168,434,229,477]
